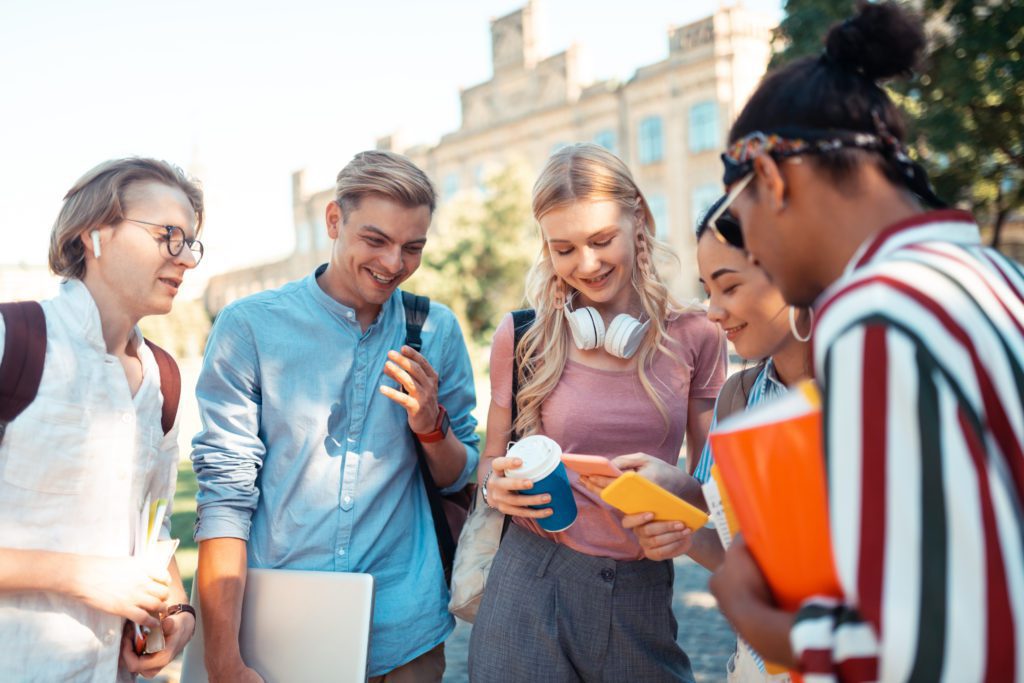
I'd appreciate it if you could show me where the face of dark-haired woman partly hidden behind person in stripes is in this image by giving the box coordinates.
[697,231,790,360]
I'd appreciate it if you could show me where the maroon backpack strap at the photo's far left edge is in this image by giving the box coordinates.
[0,301,46,442]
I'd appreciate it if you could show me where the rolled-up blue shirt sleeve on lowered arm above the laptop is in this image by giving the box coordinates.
[191,306,266,541]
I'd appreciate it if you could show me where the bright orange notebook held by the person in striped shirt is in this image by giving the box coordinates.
[710,382,842,611]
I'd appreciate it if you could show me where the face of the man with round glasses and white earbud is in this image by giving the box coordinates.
[79,182,196,321]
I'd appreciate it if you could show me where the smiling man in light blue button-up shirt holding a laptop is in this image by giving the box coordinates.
[193,152,478,682]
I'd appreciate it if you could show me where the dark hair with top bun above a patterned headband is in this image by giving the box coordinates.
[729,0,925,182]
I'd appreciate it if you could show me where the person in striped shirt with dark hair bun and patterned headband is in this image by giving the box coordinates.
[711,3,1024,681]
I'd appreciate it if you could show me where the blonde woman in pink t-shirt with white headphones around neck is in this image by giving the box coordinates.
[469,143,726,682]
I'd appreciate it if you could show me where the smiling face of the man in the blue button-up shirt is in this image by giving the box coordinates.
[323,195,430,319]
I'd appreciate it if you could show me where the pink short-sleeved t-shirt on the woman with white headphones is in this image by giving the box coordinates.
[490,312,726,560]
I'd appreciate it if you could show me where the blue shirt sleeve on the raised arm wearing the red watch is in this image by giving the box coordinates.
[437,312,480,494]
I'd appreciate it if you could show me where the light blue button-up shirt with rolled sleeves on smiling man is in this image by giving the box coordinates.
[191,266,479,676]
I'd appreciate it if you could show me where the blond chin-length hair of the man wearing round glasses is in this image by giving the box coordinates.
[49,157,203,280]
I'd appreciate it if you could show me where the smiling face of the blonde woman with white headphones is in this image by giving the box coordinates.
[540,200,637,311]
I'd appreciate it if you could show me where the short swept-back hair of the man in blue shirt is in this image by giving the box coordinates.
[335,151,437,220]
